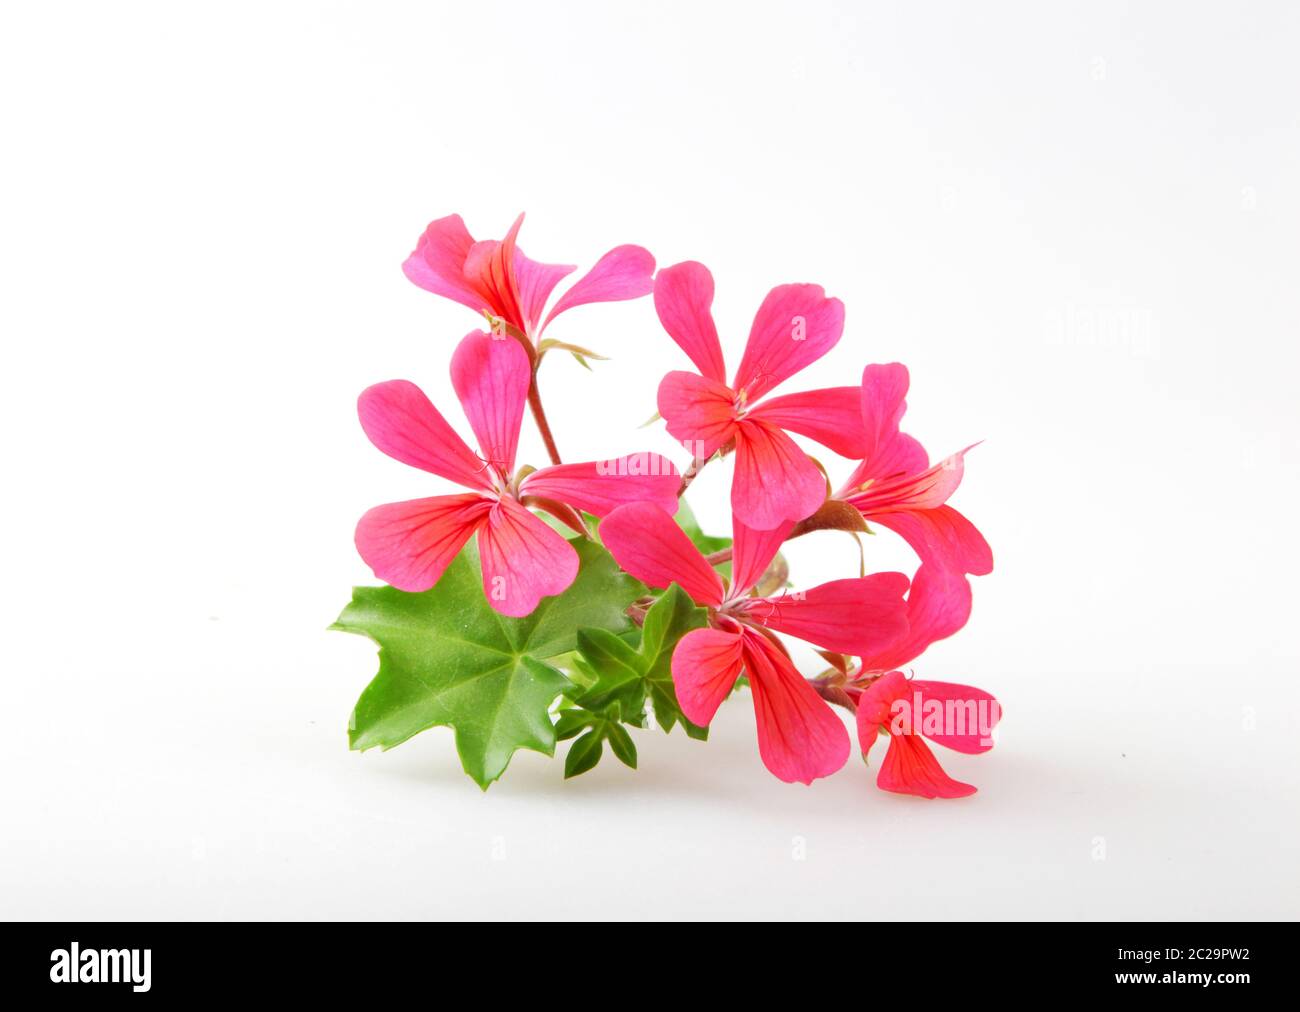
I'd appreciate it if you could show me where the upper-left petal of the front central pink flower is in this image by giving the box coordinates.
[599,502,723,606]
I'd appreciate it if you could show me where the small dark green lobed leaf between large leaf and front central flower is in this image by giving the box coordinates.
[575,584,709,740]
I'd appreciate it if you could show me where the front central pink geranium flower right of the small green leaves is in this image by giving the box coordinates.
[599,502,907,783]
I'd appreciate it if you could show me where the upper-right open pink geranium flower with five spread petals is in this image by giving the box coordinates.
[654,261,863,531]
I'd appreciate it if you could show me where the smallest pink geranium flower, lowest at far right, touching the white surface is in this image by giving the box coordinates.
[848,566,1002,797]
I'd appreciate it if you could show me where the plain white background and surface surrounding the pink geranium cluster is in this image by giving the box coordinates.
[0,0,1300,920]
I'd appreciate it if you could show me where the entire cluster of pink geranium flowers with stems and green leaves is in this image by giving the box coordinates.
[340,215,1000,797]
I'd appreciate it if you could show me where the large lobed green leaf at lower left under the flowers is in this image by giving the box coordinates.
[332,541,644,790]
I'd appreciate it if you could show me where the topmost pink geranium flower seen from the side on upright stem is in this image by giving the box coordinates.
[402,215,654,343]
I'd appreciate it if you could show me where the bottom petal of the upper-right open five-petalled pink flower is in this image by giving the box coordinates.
[733,416,826,531]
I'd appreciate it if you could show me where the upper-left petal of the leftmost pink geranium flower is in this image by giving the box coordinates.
[356,380,493,489]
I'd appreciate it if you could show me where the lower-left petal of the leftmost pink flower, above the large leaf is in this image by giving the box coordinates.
[356,496,491,592]
